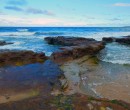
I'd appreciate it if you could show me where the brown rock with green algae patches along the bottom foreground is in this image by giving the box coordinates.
[0,94,130,110]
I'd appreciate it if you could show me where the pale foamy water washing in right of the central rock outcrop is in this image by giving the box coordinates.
[99,43,130,64]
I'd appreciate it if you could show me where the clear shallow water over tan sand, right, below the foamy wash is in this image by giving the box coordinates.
[80,61,130,102]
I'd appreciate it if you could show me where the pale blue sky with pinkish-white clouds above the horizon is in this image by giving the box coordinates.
[0,0,130,27]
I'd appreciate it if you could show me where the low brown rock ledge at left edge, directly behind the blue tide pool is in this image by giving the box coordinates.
[0,51,47,66]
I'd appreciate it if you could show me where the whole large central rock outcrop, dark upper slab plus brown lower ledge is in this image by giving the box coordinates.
[45,37,105,63]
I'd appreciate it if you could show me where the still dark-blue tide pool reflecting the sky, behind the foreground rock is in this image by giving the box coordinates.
[0,60,63,103]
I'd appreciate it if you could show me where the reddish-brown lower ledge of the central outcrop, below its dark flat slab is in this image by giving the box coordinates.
[51,43,104,62]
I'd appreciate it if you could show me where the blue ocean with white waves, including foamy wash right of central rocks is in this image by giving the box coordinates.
[0,27,130,64]
